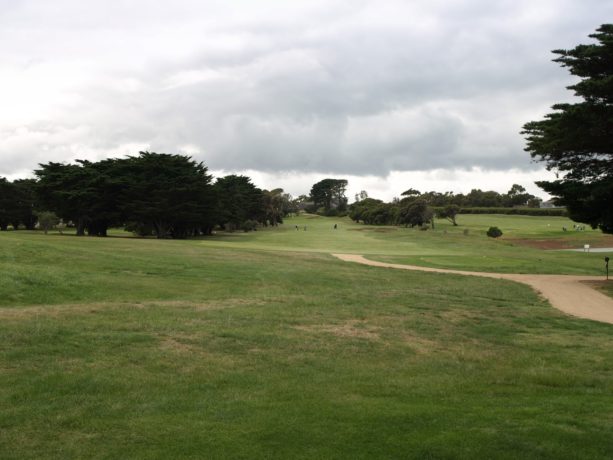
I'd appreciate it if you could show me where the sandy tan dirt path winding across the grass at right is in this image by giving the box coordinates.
[332,254,613,324]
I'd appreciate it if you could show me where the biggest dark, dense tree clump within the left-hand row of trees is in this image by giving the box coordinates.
[35,152,215,238]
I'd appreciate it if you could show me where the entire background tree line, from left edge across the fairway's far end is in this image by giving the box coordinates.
[0,156,539,238]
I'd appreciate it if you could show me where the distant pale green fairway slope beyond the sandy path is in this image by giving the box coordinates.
[201,215,613,275]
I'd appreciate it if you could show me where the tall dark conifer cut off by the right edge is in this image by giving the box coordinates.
[522,24,613,233]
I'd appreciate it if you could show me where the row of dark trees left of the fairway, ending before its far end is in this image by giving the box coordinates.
[0,152,295,238]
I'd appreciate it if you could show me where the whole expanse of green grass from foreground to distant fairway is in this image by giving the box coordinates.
[0,216,613,459]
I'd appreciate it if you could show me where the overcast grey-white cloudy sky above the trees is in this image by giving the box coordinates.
[0,0,613,199]
